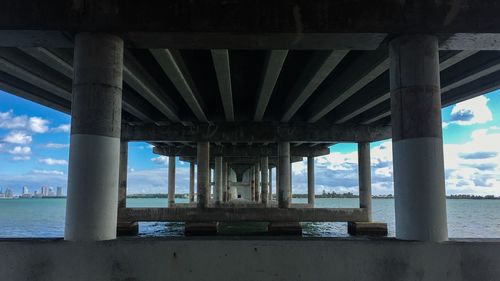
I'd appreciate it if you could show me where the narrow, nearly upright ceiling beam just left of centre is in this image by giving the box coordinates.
[211,49,234,122]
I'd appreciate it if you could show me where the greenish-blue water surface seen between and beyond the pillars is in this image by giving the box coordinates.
[0,198,500,238]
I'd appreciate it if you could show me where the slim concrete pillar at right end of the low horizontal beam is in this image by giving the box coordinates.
[358,142,372,221]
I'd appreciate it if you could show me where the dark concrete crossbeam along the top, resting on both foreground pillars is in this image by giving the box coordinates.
[4,0,500,50]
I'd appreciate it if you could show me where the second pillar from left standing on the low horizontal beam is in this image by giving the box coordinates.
[197,142,210,208]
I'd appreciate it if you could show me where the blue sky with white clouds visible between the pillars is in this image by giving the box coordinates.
[0,91,500,196]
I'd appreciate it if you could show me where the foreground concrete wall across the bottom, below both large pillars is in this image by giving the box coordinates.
[0,238,500,281]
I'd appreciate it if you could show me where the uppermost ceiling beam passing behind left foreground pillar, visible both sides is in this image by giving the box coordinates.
[20,47,153,123]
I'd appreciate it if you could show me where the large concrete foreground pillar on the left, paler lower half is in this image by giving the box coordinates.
[64,33,123,241]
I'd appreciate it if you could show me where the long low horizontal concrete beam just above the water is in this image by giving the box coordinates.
[119,208,368,222]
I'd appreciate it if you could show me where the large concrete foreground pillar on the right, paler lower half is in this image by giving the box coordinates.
[389,35,448,241]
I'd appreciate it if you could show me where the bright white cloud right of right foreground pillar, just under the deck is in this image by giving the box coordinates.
[450,96,493,125]
